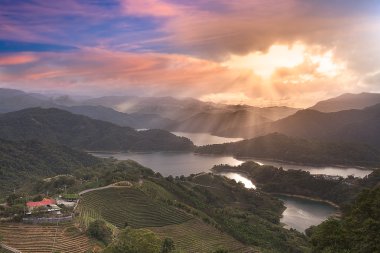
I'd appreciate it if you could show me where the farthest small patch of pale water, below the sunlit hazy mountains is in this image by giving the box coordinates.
[172,132,243,146]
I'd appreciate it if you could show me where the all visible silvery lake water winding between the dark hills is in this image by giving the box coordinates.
[92,132,360,232]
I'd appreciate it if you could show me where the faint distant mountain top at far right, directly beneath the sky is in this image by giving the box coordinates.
[310,92,380,112]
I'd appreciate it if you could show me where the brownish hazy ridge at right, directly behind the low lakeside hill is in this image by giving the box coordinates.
[224,104,380,148]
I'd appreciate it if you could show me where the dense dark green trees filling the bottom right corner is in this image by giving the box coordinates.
[306,186,380,253]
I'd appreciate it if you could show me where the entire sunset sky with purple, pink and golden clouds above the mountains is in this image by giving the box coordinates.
[0,0,380,107]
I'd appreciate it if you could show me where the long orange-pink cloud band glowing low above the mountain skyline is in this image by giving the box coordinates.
[0,48,360,107]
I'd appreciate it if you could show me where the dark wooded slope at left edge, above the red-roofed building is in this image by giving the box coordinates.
[0,139,101,196]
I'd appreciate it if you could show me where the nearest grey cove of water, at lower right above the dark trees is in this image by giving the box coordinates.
[278,196,337,232]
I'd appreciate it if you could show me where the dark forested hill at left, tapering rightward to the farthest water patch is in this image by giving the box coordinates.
[0,108,194,151]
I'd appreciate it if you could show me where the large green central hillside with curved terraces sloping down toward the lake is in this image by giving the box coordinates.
[77,171,308,252]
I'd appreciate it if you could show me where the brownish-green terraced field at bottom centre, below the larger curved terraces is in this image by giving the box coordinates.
[148,219,255,253]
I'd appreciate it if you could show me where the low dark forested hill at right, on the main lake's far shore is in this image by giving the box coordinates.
[196,133,380,167]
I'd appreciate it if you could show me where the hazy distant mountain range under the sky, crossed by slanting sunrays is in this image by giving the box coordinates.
[0,89,298,133]
